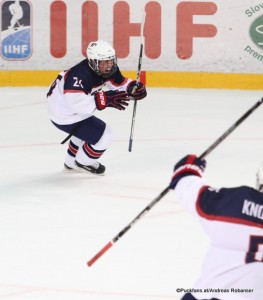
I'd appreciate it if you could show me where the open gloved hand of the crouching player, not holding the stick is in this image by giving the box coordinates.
[94,91,130,110]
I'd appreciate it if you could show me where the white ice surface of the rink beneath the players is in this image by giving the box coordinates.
[0,87,263,300]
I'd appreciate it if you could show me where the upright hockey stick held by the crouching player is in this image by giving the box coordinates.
[128,12,146,152]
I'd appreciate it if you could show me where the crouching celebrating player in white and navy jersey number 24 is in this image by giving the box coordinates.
[47,40,147,175]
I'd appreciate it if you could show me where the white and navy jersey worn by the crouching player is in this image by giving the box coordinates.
[47,59,131,125]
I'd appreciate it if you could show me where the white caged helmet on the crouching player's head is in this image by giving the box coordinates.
[86,40,117,78]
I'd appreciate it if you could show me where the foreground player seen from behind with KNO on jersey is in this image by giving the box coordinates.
[170,155,263,300]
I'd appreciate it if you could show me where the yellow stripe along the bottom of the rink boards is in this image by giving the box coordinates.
[0,70,263,90]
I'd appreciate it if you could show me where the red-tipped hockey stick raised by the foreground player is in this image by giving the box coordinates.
[87,98,263,267]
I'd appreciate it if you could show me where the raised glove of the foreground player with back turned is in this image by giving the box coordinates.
[170,154,206,189]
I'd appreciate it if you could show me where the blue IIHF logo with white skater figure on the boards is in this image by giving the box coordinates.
[1,0,32,60]
